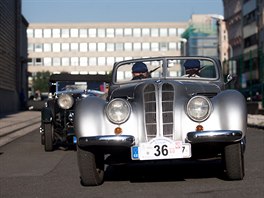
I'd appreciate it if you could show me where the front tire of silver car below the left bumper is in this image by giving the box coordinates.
[77,146,104,186]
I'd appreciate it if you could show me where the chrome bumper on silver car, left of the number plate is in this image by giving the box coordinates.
[78,135,135,147]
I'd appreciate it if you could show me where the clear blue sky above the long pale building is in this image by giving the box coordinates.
[22,0,223,23]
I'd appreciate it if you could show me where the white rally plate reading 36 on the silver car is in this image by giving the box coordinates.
[131,137,191,160]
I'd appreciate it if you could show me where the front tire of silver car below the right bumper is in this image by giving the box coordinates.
[224,142,245,180]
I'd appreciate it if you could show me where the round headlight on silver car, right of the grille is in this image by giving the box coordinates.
[187,96,212,122]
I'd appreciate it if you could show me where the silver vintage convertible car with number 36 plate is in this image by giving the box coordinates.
[74,56,247,186]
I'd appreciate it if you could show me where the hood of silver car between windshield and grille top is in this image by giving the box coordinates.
[109,80,221,99]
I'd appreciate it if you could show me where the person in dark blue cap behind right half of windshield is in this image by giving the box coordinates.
[183,59,201,77]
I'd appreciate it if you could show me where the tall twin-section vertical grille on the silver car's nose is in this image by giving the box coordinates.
[144,83,174,141]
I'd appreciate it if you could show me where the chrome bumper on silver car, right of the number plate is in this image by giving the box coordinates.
[186,130,243,143]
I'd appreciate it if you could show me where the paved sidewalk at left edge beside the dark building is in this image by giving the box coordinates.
[0,111,41,146]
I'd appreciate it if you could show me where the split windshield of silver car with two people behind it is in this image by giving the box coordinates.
[114,58,219,83]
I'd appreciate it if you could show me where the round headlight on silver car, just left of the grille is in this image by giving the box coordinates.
[106,98,131,124]
